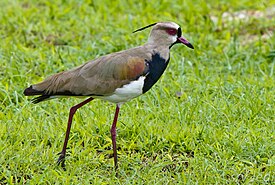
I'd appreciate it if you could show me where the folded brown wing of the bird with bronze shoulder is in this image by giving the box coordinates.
[28,47,148,96]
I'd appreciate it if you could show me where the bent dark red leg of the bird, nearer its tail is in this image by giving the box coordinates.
[57,97,93,169]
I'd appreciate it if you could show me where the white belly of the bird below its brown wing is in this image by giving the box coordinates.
[95,76,145,103]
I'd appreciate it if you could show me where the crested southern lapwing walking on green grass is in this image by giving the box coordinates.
[24,22,194,172]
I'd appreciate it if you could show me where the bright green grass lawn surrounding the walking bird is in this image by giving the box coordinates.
[0,0,275,184]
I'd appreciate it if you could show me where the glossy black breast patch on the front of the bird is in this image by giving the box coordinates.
[142,53,170,93]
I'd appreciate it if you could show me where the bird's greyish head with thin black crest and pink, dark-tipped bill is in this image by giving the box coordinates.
[134,22,194,49]
